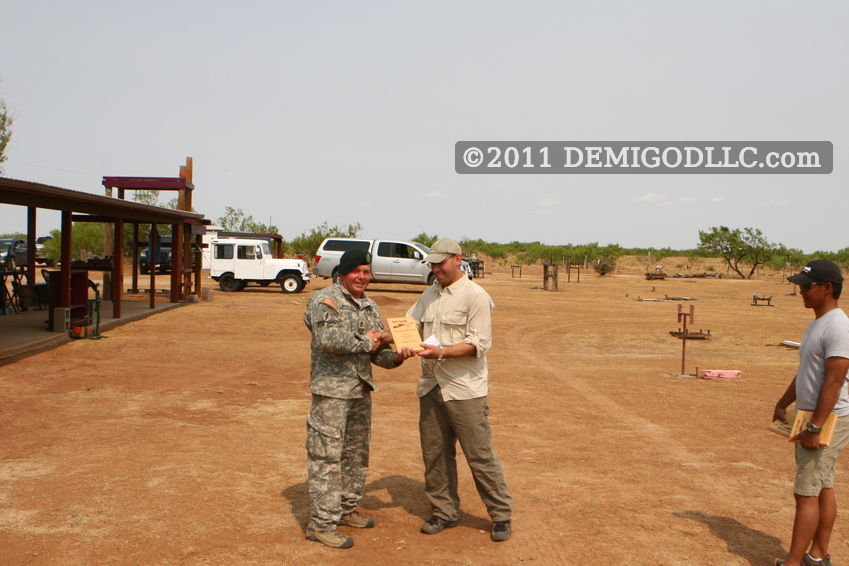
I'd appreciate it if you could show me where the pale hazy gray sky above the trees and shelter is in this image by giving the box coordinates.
[0,0,849,252]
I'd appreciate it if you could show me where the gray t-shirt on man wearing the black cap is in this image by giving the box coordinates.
[796,309,849,417]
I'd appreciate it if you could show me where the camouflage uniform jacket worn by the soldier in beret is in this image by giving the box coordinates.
[304,283,400,399]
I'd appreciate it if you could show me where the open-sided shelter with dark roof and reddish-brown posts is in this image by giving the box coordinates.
[0,177,208,328]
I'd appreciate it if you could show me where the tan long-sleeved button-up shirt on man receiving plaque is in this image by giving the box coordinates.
[407,275,495,401]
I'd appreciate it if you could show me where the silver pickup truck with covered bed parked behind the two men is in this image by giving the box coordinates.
[313,238,433,285]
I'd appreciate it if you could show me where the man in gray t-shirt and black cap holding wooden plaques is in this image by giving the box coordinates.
[773,259,849,566]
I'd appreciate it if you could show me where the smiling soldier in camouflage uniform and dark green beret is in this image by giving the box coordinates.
[304,250,414,548]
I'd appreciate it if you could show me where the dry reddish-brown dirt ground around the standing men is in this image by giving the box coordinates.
[0,266,849,566]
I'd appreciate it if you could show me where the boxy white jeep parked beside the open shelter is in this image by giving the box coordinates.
[209,238,311,293]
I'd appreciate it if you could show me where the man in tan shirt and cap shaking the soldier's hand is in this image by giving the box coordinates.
[408,238,513,541]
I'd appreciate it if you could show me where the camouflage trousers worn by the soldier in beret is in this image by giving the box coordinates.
[307,390,371,531]
